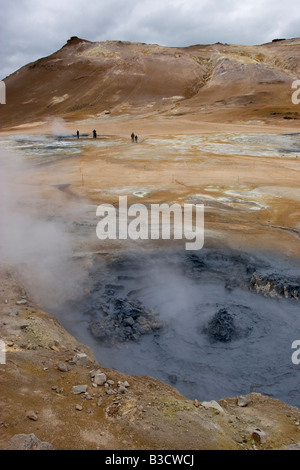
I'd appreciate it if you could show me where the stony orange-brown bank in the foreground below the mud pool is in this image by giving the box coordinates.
[0,267,300,450]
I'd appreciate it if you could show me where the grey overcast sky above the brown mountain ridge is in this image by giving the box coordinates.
[0,0,300,78]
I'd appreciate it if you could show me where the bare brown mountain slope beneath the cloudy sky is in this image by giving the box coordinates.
[0,37,300,128]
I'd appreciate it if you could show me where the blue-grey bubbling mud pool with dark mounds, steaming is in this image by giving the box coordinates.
[56,249,300,406]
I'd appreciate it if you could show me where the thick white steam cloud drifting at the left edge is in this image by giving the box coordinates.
[0,147,81,308]
